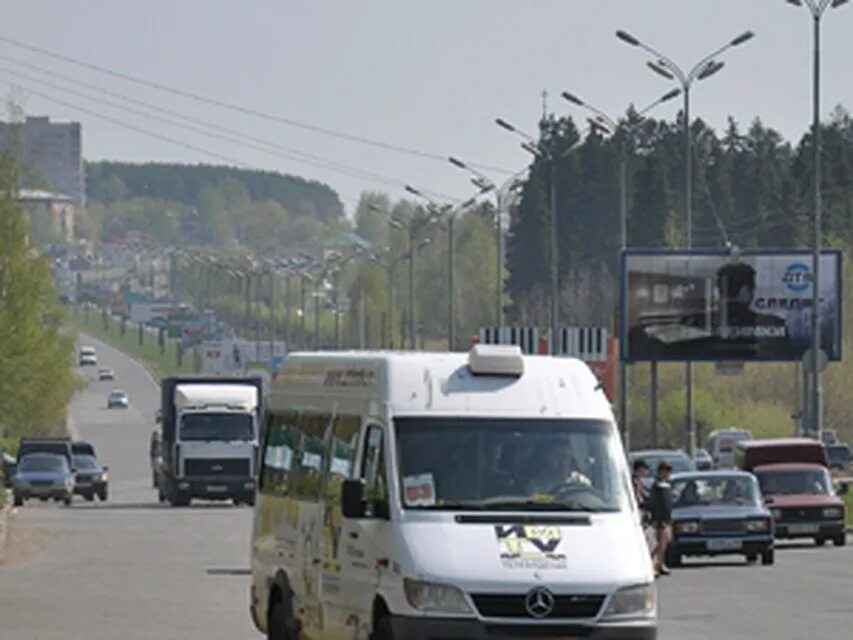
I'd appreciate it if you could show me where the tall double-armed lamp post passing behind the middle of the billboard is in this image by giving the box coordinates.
[616,30,755,456]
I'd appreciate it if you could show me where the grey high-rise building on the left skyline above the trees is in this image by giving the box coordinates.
[0,116,86,209]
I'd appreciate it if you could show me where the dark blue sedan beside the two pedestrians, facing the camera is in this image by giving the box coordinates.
[668,471,774,567]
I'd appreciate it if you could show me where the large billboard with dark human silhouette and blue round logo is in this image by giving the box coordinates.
[620,250,841,362]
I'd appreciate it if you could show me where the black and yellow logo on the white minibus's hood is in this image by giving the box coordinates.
[495,525,567,569]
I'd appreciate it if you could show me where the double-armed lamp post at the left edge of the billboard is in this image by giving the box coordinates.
[563,89,681,449]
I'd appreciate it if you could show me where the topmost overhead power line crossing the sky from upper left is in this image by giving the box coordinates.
[0,35,512,175]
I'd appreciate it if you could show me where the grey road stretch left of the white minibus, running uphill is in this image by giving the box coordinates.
[0,340,260,640]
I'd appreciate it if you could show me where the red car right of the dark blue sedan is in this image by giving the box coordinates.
[753,462,847,547]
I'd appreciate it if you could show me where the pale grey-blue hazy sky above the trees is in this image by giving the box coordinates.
[6,0,853,212]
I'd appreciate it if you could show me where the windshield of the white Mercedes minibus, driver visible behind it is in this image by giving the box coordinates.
[395,418,628,512]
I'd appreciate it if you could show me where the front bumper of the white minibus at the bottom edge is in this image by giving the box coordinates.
[391,616,657,640]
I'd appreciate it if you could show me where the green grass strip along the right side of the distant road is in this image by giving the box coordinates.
[71,309,196,377]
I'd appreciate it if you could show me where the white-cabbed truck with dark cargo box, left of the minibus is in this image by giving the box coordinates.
[155,377,263,506]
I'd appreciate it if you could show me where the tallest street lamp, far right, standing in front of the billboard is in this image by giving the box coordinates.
[788,0,847,440]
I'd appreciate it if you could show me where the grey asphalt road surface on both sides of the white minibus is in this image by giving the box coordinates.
[0,340,853,640]
